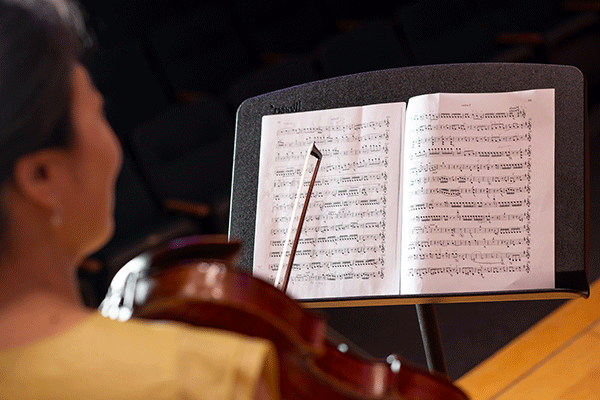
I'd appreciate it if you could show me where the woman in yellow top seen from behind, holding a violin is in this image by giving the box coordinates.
[0,0,277,399]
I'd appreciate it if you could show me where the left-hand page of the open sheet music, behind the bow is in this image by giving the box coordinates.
[253,103,405,299]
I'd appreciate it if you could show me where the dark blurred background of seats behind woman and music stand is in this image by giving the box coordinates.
[75,0,600,379]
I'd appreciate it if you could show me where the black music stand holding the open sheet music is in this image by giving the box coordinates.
[229,63,589,373]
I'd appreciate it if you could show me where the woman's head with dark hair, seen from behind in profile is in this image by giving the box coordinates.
[0,0,121,257]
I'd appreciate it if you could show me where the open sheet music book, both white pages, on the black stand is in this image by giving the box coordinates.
[253,89,555,299]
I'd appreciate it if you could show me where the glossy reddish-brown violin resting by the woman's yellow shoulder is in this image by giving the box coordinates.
[133,236,467,400]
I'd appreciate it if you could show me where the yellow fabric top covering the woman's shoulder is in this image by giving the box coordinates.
[0,314,277,398]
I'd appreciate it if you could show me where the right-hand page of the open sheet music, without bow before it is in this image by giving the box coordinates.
[400,89,554,294]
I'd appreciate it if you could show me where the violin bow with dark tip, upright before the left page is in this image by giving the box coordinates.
[274,143,323,293]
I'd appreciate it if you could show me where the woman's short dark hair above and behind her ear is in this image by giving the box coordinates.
[0,0,81,238]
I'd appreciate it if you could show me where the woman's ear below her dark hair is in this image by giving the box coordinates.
[13,149,66,212]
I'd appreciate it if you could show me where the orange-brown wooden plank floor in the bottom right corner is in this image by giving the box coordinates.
[455,280,600,400]
